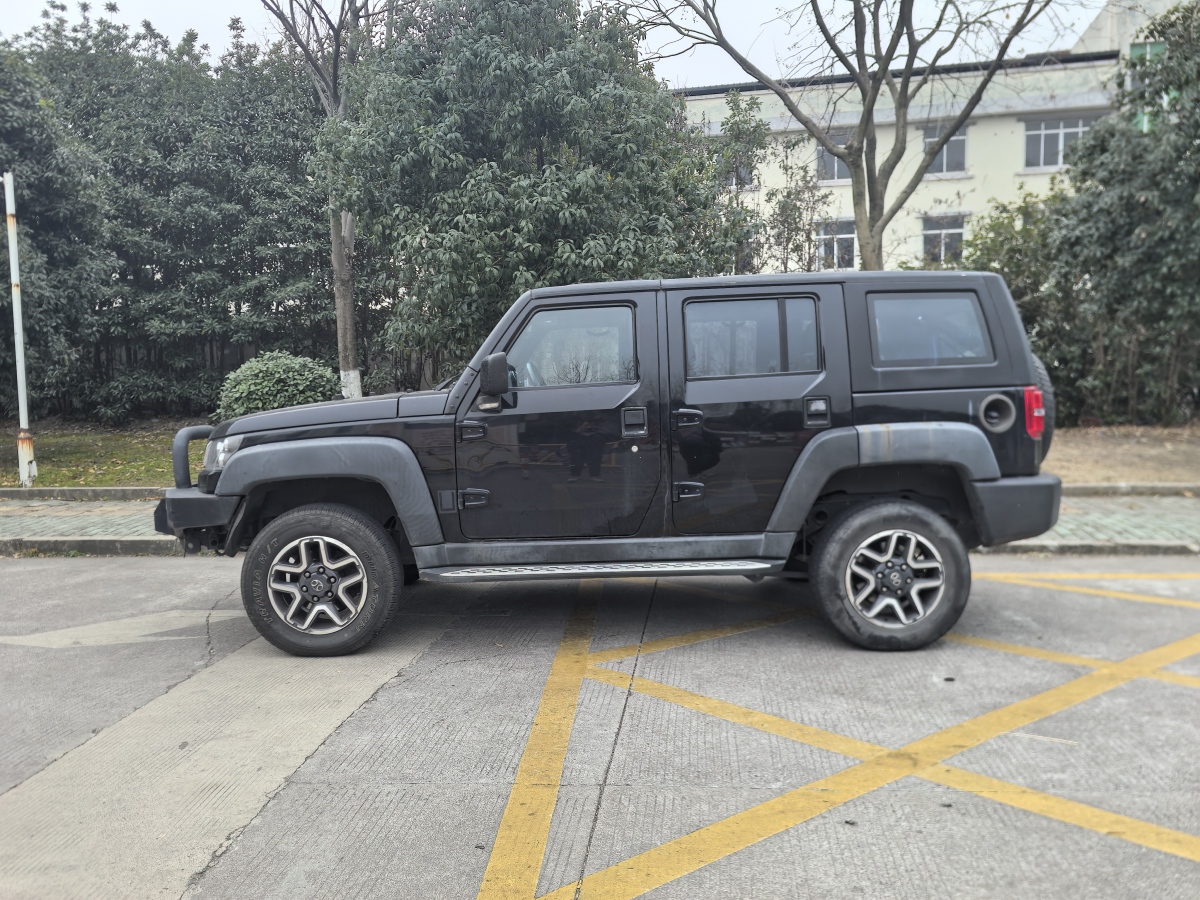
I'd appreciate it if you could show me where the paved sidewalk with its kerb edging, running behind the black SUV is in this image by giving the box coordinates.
[0,496,1200,554]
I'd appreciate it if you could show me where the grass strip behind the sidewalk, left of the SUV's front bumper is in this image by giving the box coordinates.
[0,419,208,487]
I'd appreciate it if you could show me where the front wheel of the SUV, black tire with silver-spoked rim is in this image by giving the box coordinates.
[241,503,403,656]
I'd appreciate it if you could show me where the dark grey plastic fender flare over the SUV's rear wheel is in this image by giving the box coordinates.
[767,422,1000,532]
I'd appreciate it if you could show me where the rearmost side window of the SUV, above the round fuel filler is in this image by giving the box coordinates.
[866,294,995,367]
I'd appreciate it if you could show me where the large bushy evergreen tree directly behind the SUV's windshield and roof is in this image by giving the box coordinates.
[320,0,745,386]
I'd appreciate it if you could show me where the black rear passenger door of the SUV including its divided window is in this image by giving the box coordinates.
[667,284,852,534]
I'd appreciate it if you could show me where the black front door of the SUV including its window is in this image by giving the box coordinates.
[456,292,662,540]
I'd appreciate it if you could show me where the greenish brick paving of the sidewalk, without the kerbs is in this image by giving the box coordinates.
[7,496,1200,545]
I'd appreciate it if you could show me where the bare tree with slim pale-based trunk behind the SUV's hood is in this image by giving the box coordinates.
[262,0,378,397]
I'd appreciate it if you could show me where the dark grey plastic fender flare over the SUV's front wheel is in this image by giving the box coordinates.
[216,437,444,547]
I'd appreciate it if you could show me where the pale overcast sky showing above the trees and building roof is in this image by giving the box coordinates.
[0,0,1098,88]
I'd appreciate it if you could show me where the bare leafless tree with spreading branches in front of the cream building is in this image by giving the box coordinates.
[630,0,1052,269]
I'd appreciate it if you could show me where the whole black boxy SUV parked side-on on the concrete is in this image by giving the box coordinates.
[156,272,1061,655]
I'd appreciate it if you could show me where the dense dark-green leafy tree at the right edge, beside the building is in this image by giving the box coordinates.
[1054,4,1200,422]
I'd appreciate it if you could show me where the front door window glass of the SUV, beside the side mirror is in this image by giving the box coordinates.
[508,306,637,388]
